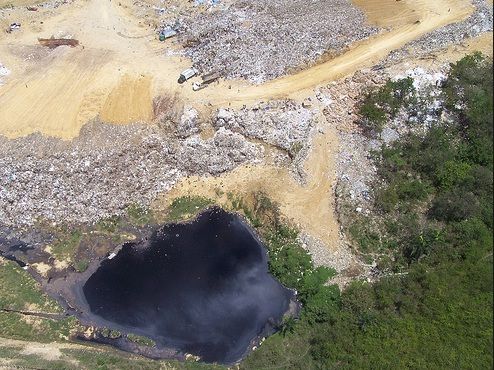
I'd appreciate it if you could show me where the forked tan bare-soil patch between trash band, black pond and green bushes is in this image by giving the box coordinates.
[155,109,340,251]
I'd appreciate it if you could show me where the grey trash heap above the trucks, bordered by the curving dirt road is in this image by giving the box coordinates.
[180,0,377,83]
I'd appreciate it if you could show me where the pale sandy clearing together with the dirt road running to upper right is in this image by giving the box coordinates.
[0,0,473,139]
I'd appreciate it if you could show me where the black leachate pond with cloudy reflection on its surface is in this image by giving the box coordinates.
[83,208,293,364]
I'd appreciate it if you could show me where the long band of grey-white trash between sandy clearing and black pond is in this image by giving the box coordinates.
[0,100,320,227]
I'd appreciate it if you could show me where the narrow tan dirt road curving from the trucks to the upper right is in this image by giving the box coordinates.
[191,0,473,106]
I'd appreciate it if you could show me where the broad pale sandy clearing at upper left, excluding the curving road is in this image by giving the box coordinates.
[0,0,192,139]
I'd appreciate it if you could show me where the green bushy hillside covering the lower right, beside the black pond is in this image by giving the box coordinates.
[242,54,493,369]
